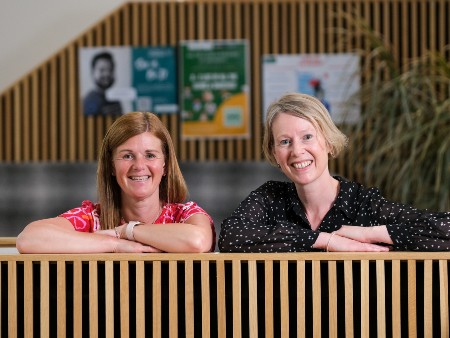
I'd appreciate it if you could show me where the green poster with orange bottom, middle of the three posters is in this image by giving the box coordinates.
[179,40,250,139]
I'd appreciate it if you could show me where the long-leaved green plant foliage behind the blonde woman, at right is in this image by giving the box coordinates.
[342,17,450,211]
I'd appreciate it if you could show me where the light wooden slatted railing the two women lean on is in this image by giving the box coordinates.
[0,252,450,338]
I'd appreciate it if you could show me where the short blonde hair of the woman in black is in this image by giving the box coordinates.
[263,93,348,166]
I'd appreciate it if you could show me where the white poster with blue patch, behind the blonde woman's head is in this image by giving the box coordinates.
[263,53,361,124]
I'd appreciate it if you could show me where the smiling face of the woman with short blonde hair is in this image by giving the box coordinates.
[272,113,329,185]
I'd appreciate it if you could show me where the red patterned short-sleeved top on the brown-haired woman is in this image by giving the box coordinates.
[59,200,216,251]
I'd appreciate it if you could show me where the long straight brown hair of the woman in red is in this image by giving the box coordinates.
[97,112,188,229]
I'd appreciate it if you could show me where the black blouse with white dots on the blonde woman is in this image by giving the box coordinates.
[219,176,450,252]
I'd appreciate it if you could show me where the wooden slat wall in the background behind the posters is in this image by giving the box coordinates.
[0,0,450,168]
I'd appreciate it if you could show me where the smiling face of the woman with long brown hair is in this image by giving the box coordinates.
[113,132,165,201]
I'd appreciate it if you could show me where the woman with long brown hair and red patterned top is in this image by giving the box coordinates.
[16,112,215,253]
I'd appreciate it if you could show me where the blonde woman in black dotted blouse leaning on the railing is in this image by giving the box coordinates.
[219,93,450,252]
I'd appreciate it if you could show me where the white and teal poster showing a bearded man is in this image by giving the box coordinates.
[79,47,178,116]
